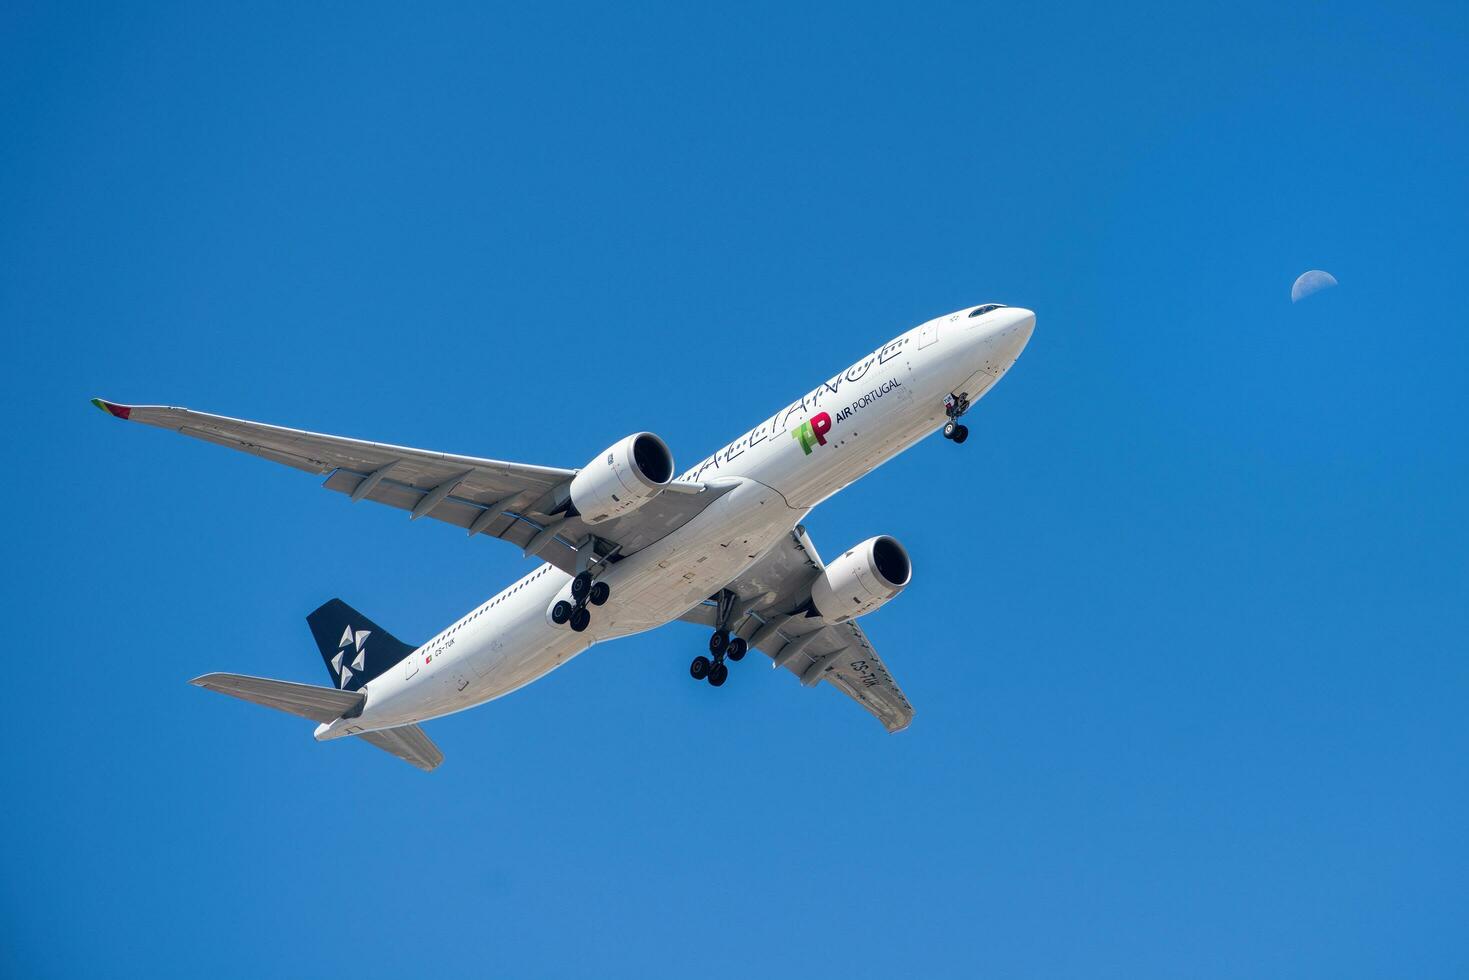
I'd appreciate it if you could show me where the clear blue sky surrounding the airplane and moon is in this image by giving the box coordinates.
[0,3,1469,977]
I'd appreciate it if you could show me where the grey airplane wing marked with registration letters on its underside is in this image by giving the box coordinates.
[680,526,914,732]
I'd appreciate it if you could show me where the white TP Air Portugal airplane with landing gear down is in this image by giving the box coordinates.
[93,303,1036,770]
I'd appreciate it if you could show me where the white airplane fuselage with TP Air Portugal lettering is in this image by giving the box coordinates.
[316,307,1036,739]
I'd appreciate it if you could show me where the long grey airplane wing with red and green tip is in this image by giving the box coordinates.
[93,398,729,573]
